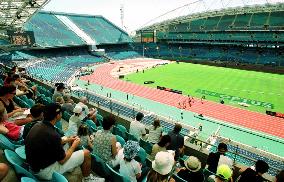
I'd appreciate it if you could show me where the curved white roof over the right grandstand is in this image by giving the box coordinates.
[137,0,284,31]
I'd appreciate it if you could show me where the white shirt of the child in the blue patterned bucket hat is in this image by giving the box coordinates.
[119,159,141,182]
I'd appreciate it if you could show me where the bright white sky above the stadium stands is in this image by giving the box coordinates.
[43,0,284,33]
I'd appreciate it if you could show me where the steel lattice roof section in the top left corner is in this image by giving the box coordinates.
[0,0,49,30]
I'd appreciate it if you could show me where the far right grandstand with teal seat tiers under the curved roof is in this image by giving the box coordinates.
[136,4,284,67]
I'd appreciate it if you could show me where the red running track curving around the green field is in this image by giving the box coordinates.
[81,60,284,138]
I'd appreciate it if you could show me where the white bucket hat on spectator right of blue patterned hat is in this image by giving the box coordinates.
[152,152,175,175]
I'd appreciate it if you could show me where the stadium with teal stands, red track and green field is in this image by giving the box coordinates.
[0,0,284,181]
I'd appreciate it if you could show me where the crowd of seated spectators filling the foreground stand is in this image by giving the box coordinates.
[0,66,283,182]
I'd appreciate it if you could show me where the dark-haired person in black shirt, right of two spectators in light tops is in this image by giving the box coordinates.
[167,123,184,161]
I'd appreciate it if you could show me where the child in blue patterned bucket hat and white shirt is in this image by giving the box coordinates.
[119,140,142,182]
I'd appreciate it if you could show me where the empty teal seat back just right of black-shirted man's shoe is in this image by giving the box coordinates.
[91,153,110,178]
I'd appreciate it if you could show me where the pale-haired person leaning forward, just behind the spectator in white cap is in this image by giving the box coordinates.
[77,97,97,123]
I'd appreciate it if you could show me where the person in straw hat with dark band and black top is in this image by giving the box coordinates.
[177,156,204,182]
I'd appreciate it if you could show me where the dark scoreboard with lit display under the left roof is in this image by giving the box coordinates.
[7,31,35,46]
